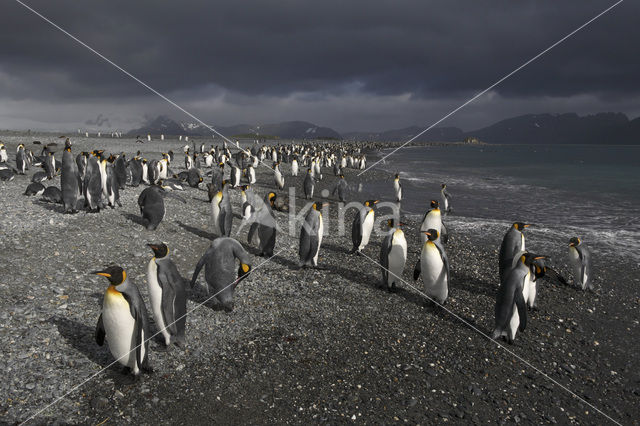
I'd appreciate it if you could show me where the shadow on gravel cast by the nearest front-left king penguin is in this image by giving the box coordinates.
[49,316,115,372]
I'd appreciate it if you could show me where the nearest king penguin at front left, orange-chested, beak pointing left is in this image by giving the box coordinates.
[93,266,153,376]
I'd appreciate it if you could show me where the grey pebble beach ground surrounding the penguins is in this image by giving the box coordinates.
[0,136,640,425]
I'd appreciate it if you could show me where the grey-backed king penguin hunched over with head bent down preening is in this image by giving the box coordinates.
[191,237,251,312]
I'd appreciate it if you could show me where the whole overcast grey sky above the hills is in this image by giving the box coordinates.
[0,0,640,131]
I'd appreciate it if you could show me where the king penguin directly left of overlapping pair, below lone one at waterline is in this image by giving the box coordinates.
[380,219,407,291]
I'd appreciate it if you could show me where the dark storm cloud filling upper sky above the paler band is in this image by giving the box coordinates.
[0,0,640,130]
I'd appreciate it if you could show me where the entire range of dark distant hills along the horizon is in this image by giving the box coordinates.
[129,112,640,145]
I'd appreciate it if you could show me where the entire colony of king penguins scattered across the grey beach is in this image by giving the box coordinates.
[0,138,593,377]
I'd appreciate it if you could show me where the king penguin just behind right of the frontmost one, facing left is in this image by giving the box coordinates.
[147,243,187,346]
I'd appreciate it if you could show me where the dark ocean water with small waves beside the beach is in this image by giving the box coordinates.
[365,145,640,261]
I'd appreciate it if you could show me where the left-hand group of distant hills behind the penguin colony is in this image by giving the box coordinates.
[128,116,342,139]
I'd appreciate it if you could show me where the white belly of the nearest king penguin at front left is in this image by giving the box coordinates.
[102,289,144,374]
